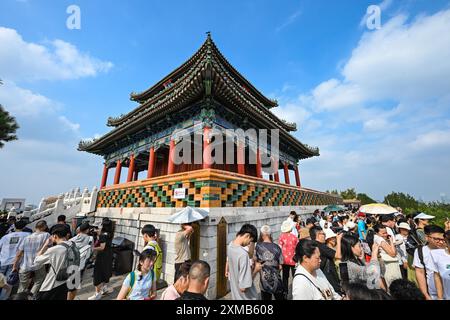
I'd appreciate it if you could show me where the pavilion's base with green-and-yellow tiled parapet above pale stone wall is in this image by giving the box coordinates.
[95,169,342,299]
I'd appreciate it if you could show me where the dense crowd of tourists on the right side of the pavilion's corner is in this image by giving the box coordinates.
[227,210,450,300]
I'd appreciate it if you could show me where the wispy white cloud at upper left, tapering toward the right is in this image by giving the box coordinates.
[0,27,113,82]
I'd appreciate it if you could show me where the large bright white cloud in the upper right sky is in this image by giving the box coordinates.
[309,10,450,114]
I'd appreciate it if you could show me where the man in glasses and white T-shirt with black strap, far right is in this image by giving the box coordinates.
[413,225,445,300]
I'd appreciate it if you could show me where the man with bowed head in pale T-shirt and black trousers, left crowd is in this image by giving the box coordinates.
[34,225,71,300]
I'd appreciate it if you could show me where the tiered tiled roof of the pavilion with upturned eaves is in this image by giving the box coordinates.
[79,33,318,157]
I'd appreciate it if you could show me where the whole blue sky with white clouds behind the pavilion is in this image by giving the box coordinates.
[0,0,450,203]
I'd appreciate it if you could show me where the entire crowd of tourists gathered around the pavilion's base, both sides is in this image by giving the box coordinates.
[0,210,450,300]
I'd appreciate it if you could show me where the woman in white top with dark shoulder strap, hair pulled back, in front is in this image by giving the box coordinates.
[292,239,342,300]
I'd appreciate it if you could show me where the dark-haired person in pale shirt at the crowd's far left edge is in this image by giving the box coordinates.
[0,220,30,277]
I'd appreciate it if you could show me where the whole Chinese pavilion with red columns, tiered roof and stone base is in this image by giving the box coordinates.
[79,33,342,298]
